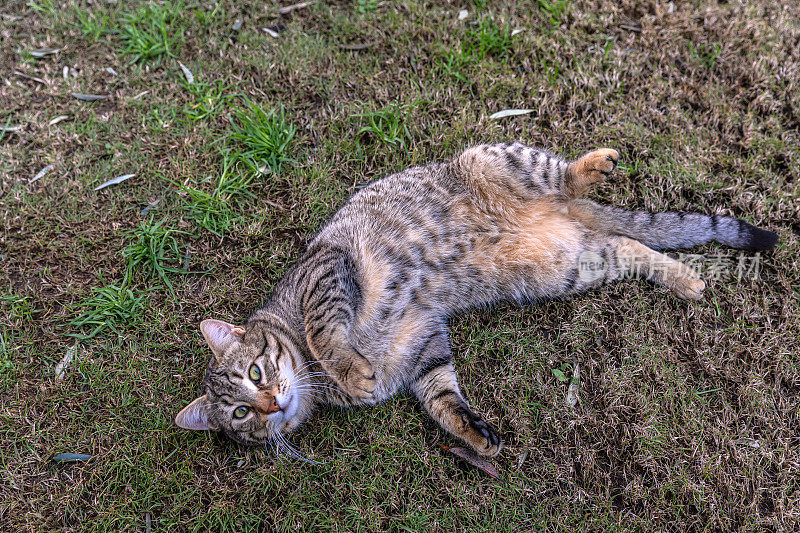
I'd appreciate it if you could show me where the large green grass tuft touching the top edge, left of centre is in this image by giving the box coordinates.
[119,1,183,63]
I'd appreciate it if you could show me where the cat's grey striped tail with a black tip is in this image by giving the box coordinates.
[569,200,778,251]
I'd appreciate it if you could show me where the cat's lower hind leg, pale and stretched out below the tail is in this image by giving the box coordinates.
[576,236,705,300]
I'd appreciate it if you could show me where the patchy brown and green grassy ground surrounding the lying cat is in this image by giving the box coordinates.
[0,0,800,531]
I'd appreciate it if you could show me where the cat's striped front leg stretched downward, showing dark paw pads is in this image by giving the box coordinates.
[411,331,503,457]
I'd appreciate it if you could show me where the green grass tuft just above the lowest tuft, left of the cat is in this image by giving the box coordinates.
[122,218,184,292]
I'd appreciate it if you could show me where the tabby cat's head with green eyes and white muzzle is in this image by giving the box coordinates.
[175,320,308,446]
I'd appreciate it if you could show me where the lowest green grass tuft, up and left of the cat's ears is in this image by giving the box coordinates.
[69,283,144,339]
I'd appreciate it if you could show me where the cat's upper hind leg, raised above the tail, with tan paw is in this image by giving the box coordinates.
[453,143,619,213]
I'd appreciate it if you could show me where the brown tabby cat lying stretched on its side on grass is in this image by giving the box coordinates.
[175,143,778,456]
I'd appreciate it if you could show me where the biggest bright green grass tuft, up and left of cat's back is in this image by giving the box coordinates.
[230,102,296,176]
